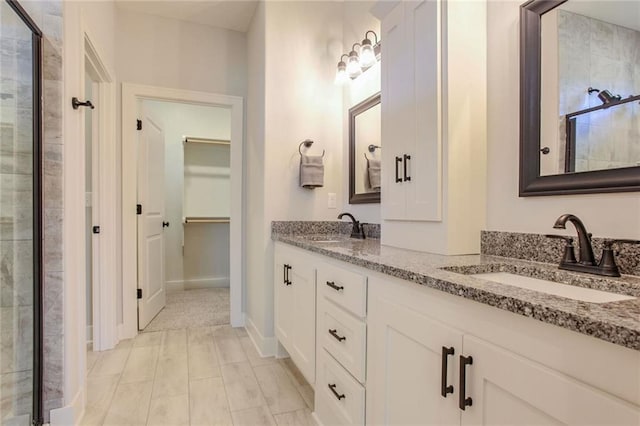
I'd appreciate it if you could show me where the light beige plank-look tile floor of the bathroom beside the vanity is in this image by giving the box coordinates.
[81,325,314,426]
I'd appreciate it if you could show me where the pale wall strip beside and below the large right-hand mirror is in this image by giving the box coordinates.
[487,1,640,239]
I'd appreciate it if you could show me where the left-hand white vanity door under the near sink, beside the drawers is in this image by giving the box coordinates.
[366,293,462,426]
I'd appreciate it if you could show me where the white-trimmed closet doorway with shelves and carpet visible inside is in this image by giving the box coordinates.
[119,83,244,339]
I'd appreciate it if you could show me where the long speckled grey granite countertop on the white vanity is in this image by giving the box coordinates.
[273,232,640,350]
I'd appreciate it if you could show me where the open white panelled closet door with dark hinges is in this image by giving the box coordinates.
[138,110,166,330]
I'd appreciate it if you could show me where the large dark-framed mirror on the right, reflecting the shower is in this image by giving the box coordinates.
[520,0,640,197]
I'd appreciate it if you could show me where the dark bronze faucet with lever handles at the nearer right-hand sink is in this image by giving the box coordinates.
[546,214,640,277]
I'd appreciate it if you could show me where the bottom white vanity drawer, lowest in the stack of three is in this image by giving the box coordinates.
[315,350,365,425]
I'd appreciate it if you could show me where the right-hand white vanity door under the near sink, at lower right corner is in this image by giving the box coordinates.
[462,336,640,426]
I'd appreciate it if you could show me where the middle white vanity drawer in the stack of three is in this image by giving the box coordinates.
[317,298,367,382]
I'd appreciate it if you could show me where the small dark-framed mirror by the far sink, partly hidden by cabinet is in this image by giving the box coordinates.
[349,93,382,204]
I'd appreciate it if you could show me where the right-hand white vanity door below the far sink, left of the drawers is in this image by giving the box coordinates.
[287,258,316,384]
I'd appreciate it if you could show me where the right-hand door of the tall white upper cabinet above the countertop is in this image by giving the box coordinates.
[402,0,442,221]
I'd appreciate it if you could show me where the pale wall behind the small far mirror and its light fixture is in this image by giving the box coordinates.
[342,1,384,223]
